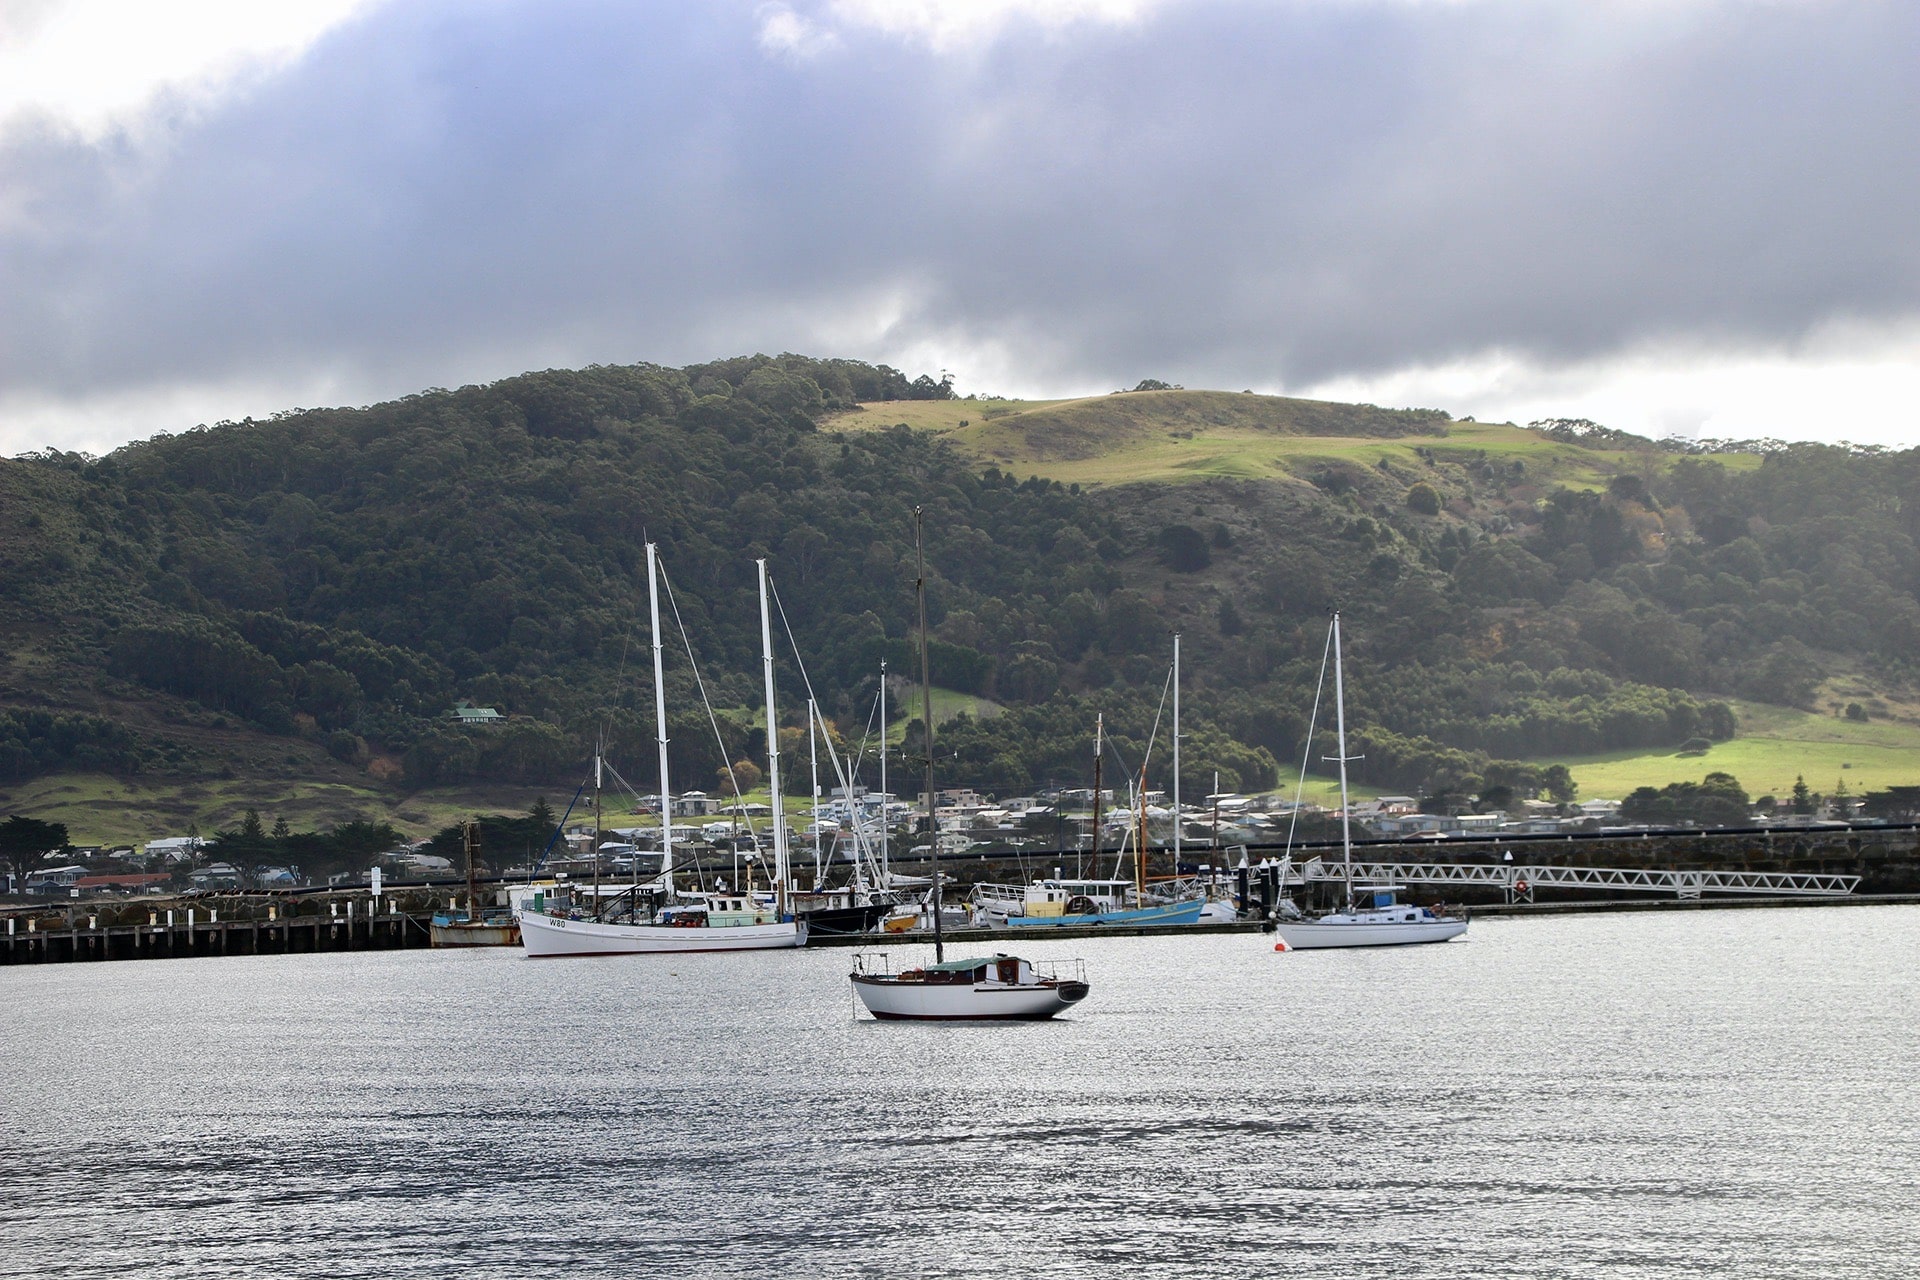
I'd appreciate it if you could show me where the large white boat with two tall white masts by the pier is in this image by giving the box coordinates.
[520,543,806,958]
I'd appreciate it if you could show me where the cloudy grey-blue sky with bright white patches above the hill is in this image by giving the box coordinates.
[0,0,1920,455]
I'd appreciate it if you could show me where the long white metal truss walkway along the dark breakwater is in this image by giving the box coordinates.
[1283,858,1860,902]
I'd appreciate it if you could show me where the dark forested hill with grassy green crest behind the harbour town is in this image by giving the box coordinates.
[0,357,1920,809]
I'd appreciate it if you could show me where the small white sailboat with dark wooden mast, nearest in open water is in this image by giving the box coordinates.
[849,507,1092,1023]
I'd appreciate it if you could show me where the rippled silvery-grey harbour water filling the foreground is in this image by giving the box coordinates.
[0,908,1920,1280]
